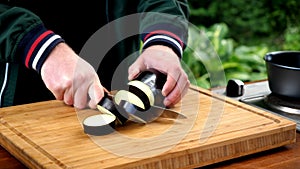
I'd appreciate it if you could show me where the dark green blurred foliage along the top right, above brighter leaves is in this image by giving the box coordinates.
[189,0,300,50]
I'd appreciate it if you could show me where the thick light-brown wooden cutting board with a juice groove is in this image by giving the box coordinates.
[0,86,296,169]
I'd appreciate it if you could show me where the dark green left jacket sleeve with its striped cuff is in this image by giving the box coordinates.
[0,4,63,71]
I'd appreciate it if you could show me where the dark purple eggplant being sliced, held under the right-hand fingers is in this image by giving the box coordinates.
[114,70,166,123]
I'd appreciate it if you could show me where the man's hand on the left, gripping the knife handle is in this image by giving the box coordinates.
[41,43,104,109]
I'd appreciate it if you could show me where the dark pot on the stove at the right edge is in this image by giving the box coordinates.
[264,51,300,98]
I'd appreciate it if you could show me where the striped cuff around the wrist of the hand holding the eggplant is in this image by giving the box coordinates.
[143,30,184,58]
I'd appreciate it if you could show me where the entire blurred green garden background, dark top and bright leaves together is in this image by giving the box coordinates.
[183,0,300,88]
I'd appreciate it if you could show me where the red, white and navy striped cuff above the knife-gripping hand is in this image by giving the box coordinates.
[19,25,64,72]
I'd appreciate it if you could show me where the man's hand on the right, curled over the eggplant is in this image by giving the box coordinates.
[128,45,190,106]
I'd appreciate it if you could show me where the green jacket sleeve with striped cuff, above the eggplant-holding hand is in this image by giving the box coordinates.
[138,0,189,57]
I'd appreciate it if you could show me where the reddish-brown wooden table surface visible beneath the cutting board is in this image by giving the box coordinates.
[0,133,300,169]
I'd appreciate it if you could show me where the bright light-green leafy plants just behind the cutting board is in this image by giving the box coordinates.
[183,23,268,88]
